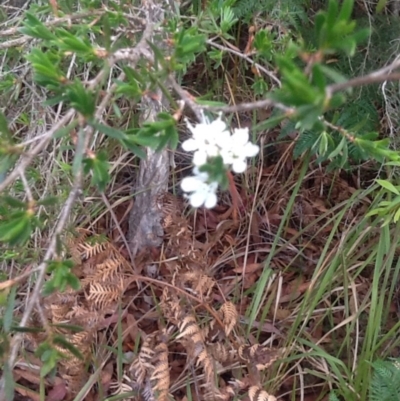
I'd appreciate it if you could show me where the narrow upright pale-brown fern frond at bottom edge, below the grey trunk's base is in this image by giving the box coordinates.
[150,342,170,401]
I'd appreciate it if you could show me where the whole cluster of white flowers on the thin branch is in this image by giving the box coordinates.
[181,111,259,209]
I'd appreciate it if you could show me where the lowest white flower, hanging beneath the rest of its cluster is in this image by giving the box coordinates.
[181,168,218,209]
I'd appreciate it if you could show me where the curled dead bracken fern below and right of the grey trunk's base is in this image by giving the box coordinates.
[123,192,282,401]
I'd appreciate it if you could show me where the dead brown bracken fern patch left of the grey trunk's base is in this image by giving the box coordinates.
[25,229,133,394]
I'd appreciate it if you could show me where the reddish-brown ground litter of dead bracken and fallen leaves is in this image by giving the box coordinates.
[11,134,384,401]
